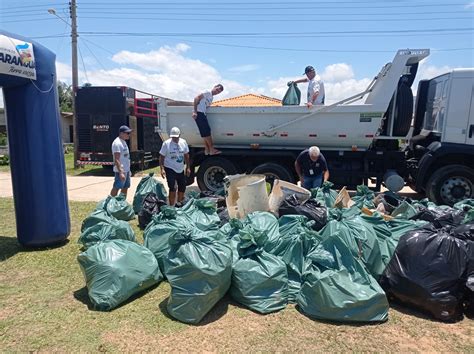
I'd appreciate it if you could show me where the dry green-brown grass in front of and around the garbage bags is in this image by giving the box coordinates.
[0,198,474,352]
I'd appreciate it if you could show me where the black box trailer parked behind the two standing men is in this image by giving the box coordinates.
[76,86,163,170]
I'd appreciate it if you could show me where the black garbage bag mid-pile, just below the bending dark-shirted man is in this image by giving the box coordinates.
[278,194,328,231]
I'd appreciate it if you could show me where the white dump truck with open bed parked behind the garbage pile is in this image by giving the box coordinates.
[156,49,474,204]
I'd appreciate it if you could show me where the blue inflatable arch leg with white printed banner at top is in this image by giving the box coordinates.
[0,31,70,247]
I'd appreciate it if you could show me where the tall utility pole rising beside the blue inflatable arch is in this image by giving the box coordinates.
[69,0,79,169]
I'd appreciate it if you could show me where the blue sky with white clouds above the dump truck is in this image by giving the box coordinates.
[0,0,474,106]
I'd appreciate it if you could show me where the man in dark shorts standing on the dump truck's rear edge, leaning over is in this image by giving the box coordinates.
[193,84,224,155]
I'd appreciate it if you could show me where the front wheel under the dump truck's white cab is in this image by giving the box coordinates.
[426,165,474,205]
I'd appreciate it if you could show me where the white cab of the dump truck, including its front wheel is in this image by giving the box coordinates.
[407,69,474,205]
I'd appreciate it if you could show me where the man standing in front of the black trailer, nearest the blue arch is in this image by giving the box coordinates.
[110,125,132,197]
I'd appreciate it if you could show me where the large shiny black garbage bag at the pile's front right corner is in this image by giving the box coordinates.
[380,225,469,322]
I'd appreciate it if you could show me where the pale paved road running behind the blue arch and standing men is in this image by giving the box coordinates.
[0,172,420,203]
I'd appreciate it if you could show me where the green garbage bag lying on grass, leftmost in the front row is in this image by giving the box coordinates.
[77,240,163,311]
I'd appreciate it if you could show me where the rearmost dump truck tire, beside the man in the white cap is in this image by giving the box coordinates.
[197,157,237,192]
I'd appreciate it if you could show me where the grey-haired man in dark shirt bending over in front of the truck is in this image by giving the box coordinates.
[295,146,329,190]
